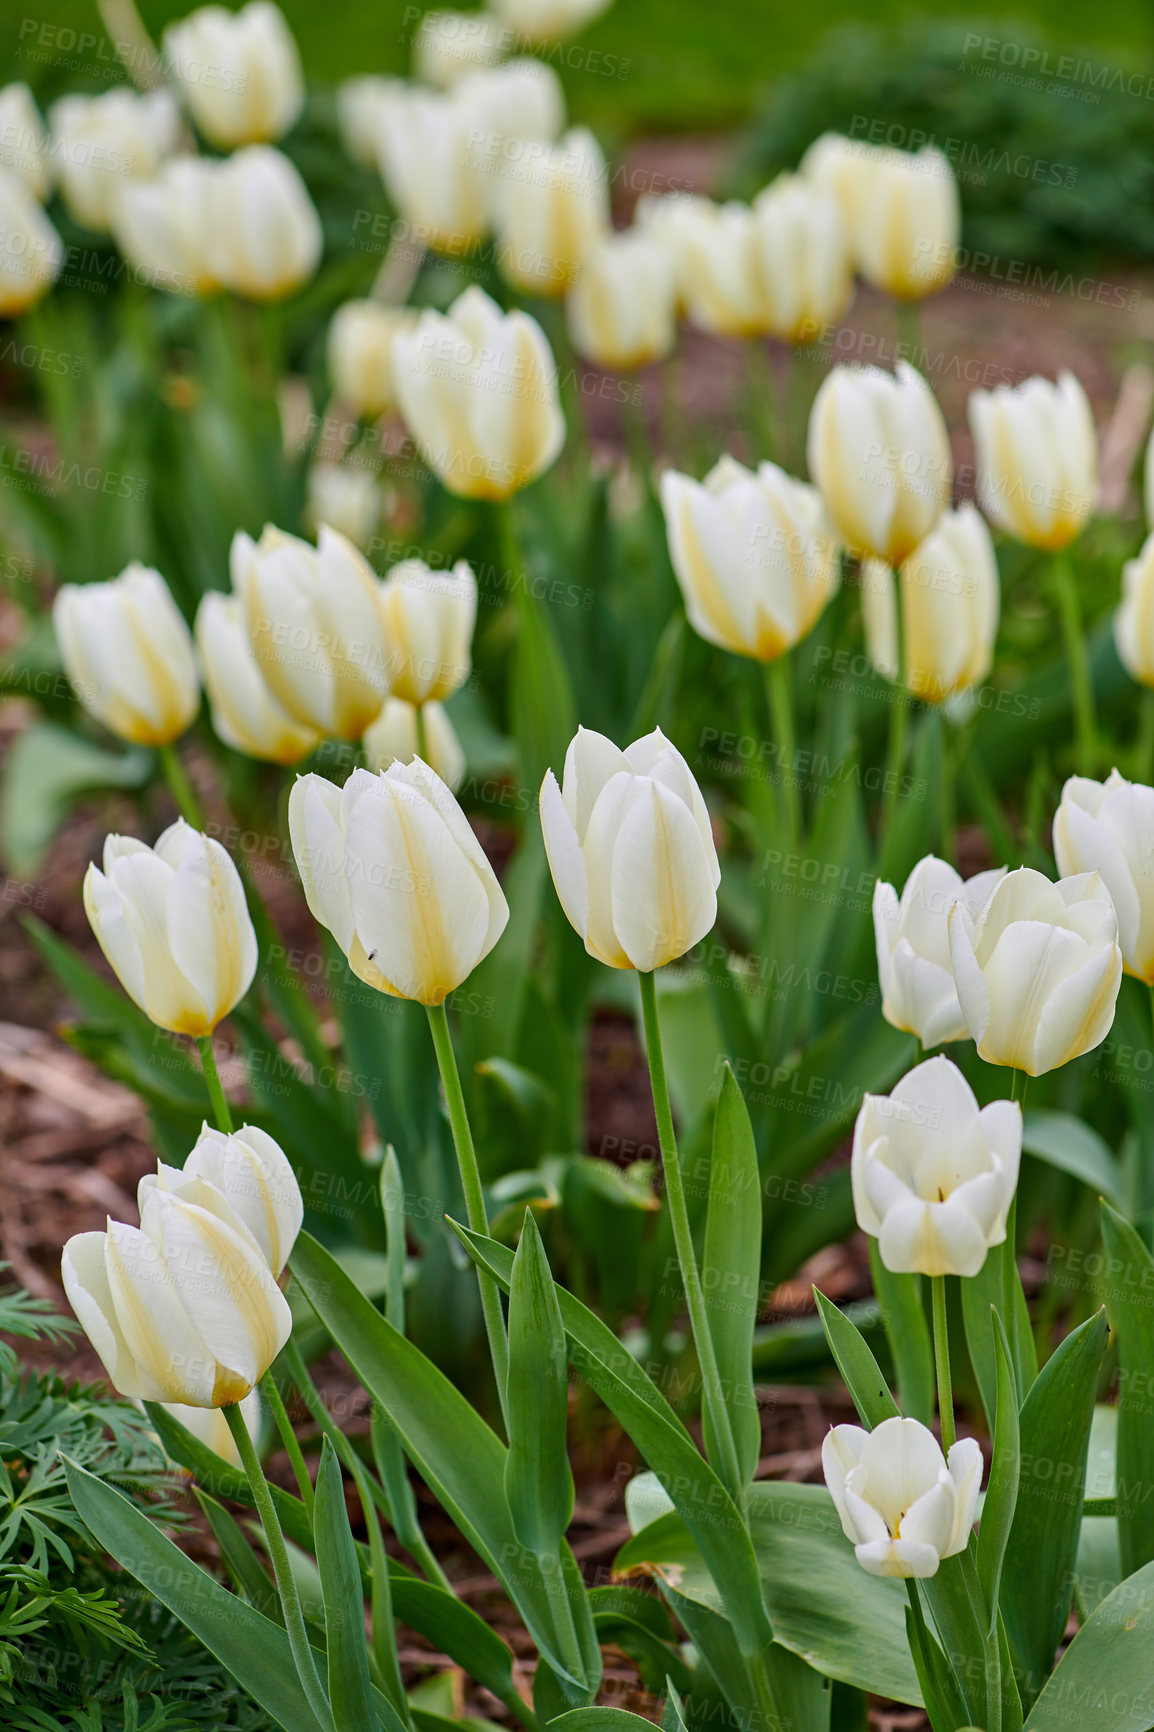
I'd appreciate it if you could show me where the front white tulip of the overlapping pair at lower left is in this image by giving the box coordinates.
[61,1173,293,1408]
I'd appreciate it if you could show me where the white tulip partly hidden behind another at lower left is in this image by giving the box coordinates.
[137,1124,305,1276]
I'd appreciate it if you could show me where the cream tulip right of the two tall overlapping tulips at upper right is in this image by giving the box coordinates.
[969,372,1099,553]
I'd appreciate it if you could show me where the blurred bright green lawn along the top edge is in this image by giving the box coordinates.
[0,0,1154,136]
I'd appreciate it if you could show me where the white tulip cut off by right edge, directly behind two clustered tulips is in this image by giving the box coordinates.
[1054,771,1154,986]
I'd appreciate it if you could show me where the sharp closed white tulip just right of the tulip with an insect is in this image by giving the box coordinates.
[541,727,721,973]
